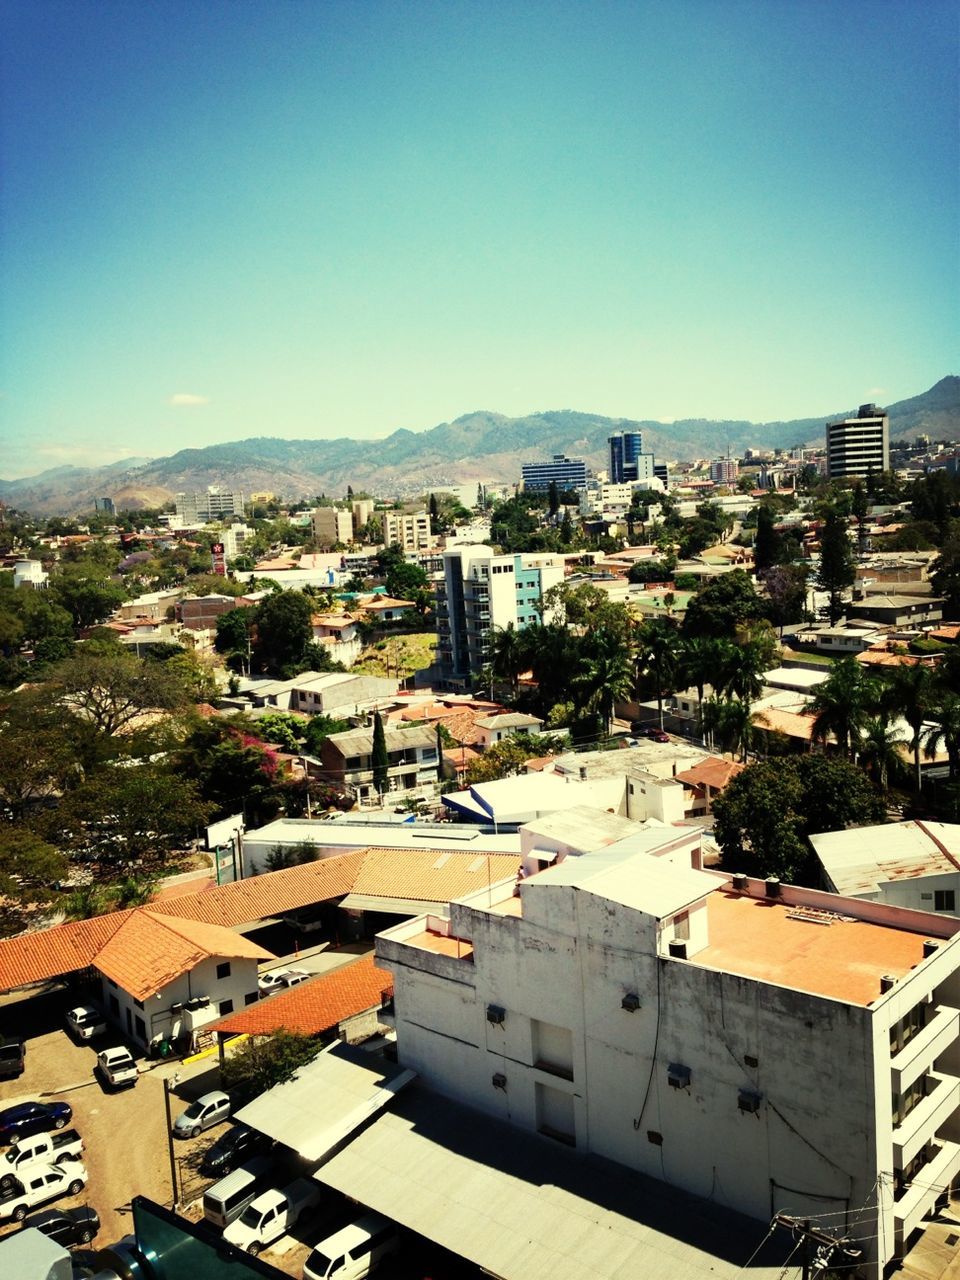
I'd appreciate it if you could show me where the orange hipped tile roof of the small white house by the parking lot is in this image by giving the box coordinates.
[95,909,273,1000]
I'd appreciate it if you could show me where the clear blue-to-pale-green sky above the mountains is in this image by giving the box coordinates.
[0,0,960,477]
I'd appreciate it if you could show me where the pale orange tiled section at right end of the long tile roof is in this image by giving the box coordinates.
[353,849,520,902]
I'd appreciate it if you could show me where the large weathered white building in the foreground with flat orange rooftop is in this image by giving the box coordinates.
[376,836,960,1277]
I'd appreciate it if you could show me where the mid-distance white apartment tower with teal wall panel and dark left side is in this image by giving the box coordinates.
[436,545,563,684]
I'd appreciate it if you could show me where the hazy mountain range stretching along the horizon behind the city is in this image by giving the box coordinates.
[0,375,960,515]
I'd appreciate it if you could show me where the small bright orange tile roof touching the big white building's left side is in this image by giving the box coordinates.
[211,955,393,1036]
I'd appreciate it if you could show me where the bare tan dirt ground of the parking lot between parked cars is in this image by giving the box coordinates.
[0,988,229,1244]
